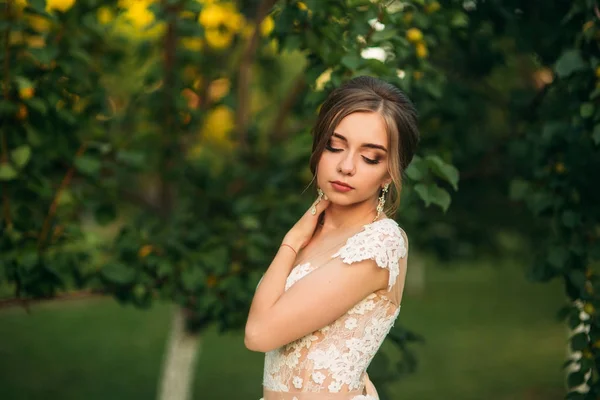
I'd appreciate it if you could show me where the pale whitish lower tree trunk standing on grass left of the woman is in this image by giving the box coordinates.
[158,308,201,400]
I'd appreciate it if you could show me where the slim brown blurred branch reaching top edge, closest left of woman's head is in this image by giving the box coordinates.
[235,0,277,147]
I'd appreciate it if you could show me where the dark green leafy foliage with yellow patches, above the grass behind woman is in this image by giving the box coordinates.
[0,0,600,398]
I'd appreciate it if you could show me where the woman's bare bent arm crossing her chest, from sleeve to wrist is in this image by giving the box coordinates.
[245,256,388,352]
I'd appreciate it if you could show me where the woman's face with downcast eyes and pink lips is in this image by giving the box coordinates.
[317,112,391,206]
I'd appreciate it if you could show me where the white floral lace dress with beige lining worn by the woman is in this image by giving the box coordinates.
[263,219,407,400]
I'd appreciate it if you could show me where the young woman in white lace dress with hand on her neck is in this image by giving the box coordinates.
[245,77,419,400]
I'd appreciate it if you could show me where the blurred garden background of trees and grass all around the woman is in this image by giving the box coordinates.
[0,0,600,400]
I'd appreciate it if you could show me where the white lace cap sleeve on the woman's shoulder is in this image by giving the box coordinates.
[332,218,407,290]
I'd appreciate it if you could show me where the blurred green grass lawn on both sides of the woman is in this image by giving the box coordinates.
[0,262,566,400]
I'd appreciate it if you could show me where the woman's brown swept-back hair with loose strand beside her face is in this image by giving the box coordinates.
[310,76,419,216]
